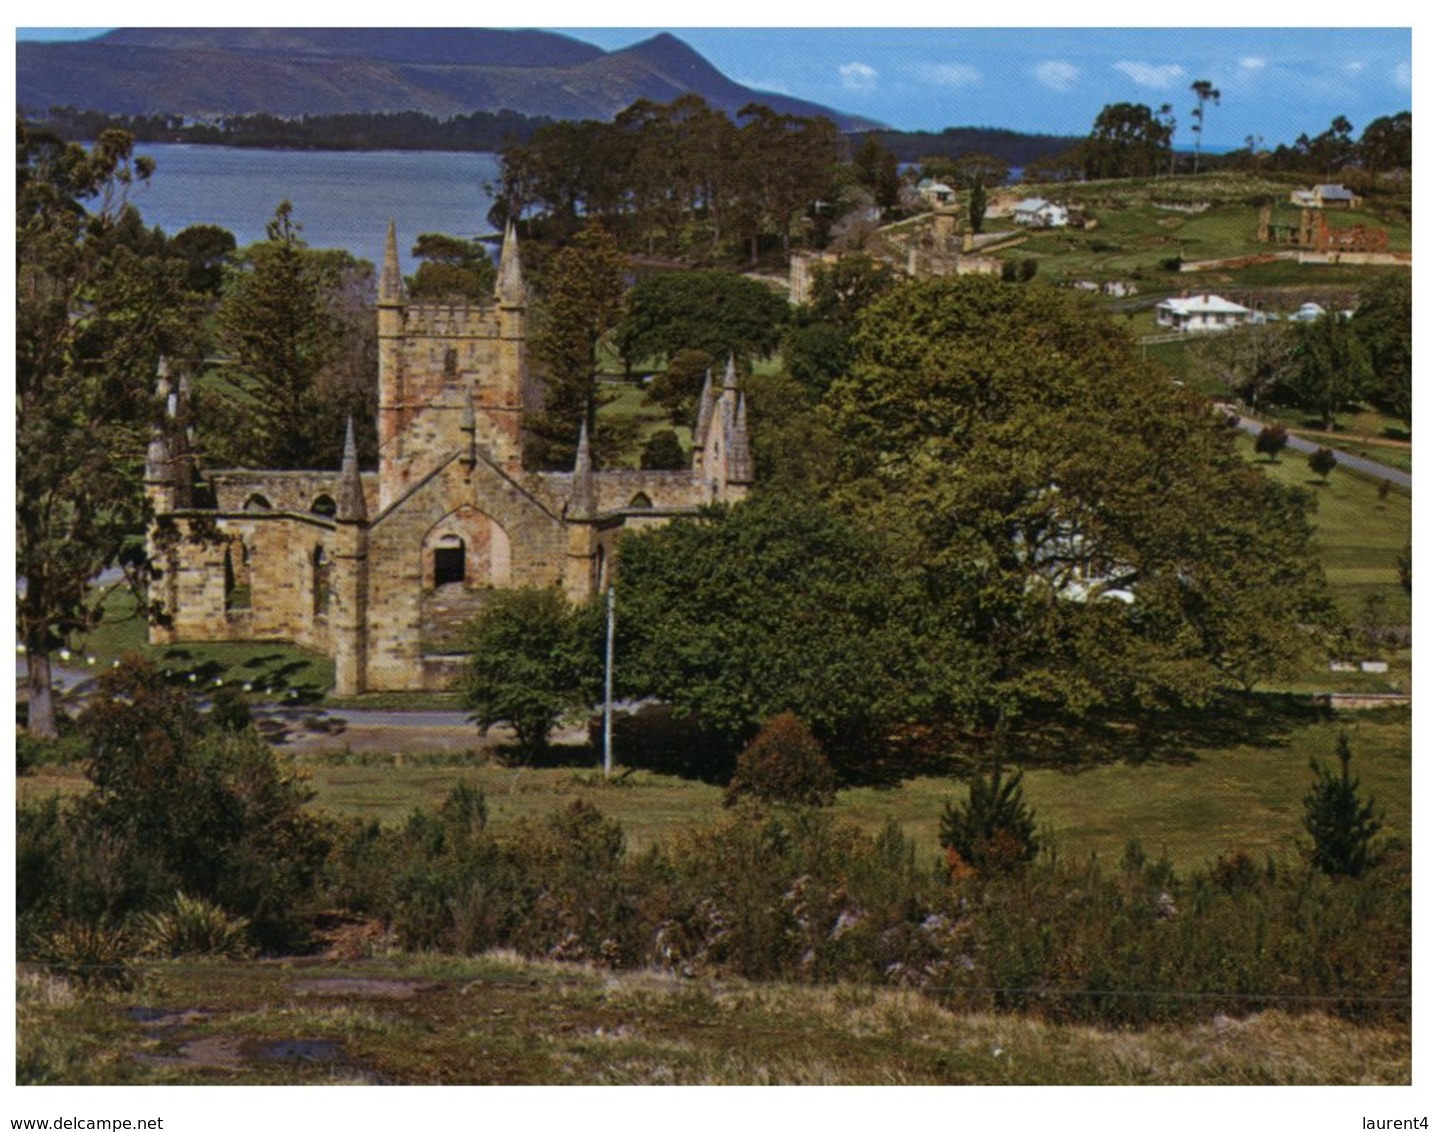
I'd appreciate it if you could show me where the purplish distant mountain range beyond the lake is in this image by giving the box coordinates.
[16,27,876,131]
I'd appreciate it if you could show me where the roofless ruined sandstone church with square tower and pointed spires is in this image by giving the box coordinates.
[145,223,753,695]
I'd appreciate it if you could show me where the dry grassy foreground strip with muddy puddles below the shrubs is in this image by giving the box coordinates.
[16,954,1410,1085]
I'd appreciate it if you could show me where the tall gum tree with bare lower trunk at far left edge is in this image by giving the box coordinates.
[14,124,199,735]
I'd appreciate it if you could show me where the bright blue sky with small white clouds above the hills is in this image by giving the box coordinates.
[20,27,1412,148]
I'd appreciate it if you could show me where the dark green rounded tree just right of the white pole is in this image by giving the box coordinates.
[616,493,968,759]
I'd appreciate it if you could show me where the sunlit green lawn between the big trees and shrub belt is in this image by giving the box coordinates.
[17,708,1412,872]
